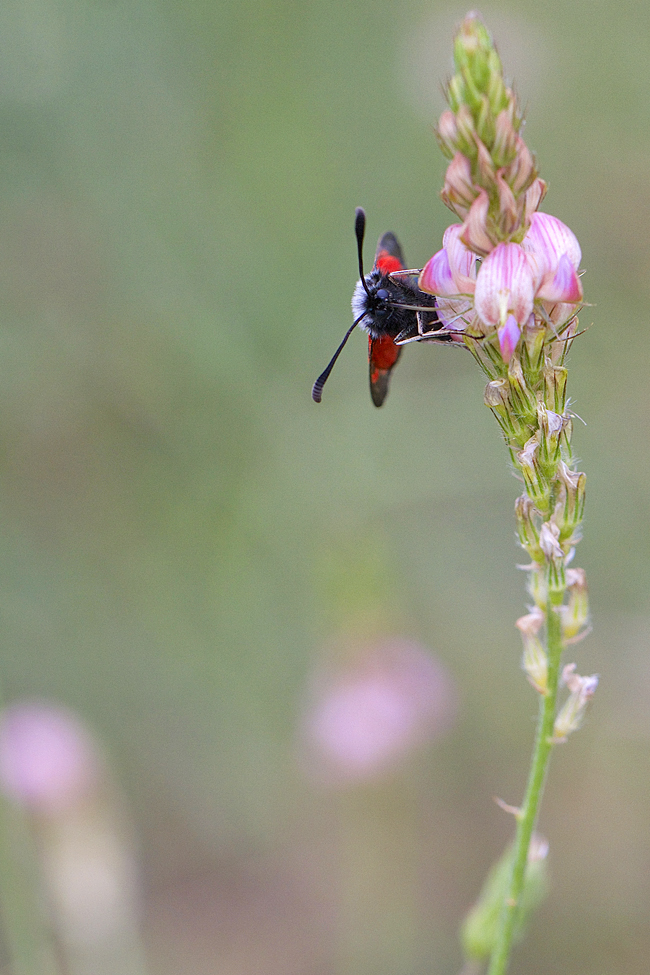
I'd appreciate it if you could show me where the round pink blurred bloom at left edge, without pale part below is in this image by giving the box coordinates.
[0,701,98,813]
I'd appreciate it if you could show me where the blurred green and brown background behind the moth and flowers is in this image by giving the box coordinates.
[0,0,650,975]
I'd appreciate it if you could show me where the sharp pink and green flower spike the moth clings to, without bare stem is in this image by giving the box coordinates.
[412,14,595,724]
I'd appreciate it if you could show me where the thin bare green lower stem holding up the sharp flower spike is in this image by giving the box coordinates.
[488,593,563,975]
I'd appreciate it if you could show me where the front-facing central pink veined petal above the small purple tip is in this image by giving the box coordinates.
[474,244,535,326]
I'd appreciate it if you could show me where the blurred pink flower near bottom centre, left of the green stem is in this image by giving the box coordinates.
[303,638,457,784]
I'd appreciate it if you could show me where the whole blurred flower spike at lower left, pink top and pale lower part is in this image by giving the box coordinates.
[0,701,143,975]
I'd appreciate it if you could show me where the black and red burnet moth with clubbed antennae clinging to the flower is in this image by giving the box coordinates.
[311,207,452,406]
